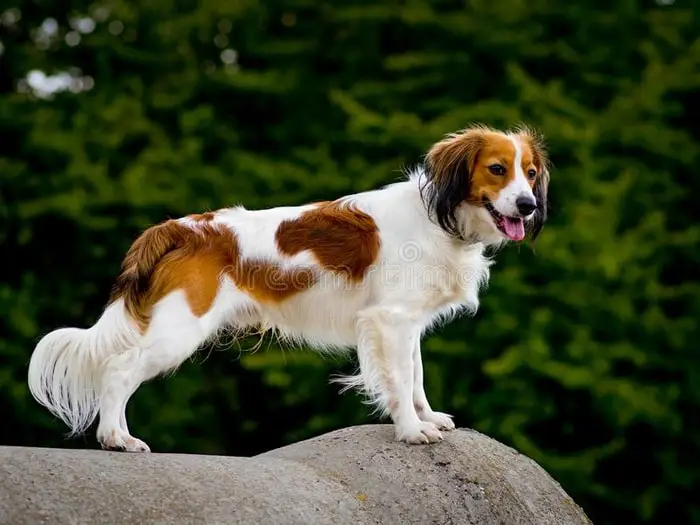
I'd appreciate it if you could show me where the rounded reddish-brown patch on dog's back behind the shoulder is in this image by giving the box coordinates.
[276,202,380,282]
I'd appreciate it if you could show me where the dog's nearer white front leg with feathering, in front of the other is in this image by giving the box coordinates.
[357,307,442,444]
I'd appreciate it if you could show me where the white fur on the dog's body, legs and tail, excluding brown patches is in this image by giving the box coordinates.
[29,170,504,451]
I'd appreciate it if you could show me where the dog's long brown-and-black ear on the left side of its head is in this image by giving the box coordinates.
[423,127,484,238]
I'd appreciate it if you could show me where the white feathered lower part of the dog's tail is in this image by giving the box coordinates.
[28,300,138,435]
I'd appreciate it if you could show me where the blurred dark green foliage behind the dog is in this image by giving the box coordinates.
[0,0,700,524]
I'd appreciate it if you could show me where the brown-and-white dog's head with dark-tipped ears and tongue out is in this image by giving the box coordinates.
[424,126,549,241]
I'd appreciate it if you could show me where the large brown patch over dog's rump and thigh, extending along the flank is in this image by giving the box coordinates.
[110,217,316,332]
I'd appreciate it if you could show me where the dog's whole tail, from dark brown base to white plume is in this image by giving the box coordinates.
[28,221,187,435]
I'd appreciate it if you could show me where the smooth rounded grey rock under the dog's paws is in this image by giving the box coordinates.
[0,425,590,525]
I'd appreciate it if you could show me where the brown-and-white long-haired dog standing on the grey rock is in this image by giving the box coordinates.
[28,125,550,452]
